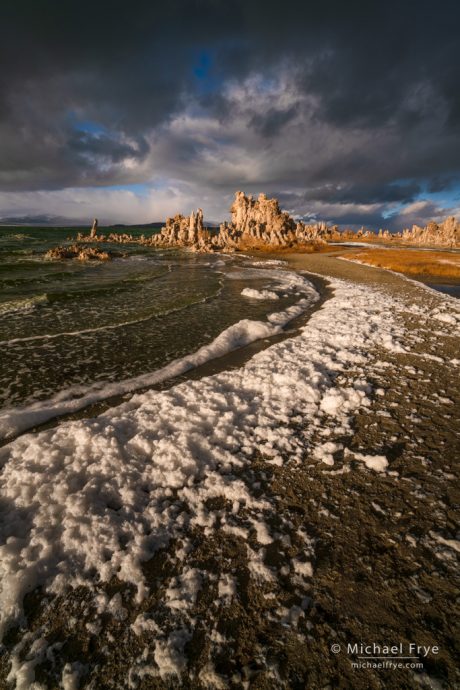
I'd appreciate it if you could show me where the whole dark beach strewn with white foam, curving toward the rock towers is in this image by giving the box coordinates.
[0,254,460,690]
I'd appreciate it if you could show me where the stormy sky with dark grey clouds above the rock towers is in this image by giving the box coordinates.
[0,0,460,230]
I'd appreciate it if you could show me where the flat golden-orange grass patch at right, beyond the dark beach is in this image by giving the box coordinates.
[343,249,460,280]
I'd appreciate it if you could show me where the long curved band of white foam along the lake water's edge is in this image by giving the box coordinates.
[0,274,319,439]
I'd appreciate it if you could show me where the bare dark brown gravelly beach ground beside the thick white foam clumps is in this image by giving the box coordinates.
[0,255,460,690]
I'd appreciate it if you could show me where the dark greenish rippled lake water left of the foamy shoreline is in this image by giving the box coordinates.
[0,228,320,432]
